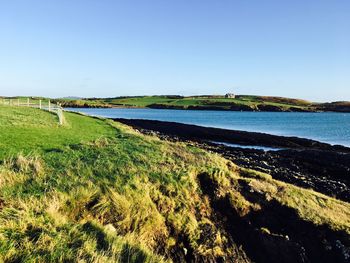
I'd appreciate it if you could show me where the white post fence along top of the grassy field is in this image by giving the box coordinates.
[0,98,65,125]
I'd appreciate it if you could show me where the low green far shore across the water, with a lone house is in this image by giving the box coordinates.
[51,95,350,112]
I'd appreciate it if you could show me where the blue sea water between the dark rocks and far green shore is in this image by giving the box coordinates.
[70,108,350,146]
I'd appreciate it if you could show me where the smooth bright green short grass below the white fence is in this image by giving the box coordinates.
[0,106,115,158]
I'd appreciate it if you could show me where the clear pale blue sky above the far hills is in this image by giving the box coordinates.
[0,0,350,101]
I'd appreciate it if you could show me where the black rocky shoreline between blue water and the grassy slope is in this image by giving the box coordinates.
[115,119,350,202]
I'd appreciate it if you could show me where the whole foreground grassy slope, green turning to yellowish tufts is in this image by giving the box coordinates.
[0,106,350,262]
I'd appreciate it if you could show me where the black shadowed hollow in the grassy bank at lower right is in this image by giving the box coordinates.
[199,174,350,263]
